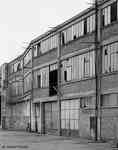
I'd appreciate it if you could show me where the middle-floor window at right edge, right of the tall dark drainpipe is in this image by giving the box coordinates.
[102,42,118,73]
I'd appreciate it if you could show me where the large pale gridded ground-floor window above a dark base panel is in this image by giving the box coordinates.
[61,99,80,131]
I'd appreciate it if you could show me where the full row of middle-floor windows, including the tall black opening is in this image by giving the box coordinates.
[9,42,118,93]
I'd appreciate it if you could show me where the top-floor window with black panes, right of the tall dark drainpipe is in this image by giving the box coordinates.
[102,1,118,26]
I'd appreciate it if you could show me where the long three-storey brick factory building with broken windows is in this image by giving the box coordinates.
[1,0,118,139]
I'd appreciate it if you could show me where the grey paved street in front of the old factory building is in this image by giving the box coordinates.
[0,130,112,150]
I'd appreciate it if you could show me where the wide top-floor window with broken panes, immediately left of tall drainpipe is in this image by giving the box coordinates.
[61,15,95,45]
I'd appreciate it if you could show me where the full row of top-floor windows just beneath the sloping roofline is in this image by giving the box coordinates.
[10,0,118,73]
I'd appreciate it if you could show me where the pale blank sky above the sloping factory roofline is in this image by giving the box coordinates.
[0,0,91,65]
